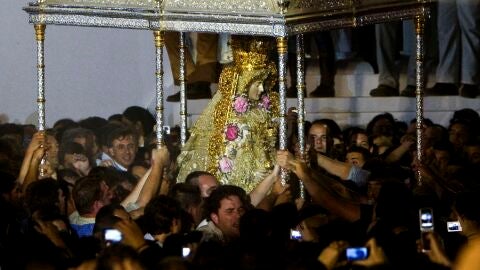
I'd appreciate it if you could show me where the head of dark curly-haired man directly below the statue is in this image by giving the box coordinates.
[205,185,249,239]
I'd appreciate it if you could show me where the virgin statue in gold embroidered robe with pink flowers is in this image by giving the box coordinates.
[177,36,279,192]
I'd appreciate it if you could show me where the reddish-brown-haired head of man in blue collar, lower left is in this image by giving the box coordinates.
[72,176,110,217]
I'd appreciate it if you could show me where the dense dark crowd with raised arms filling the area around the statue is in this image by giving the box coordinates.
[0,102,480,269]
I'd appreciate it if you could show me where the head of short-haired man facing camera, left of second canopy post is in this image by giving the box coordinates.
[107,127,138,168]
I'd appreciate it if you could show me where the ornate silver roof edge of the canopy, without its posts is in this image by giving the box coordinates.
[24,0,431,36]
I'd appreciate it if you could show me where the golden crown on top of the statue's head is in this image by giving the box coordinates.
[231,36,273,70]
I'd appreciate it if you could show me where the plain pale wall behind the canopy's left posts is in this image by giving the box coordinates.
[0,0,173,126]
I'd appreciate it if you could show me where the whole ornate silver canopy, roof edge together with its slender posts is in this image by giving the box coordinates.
[24,0,434,186]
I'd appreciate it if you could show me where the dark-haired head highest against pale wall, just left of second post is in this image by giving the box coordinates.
[122,106,155,136]
